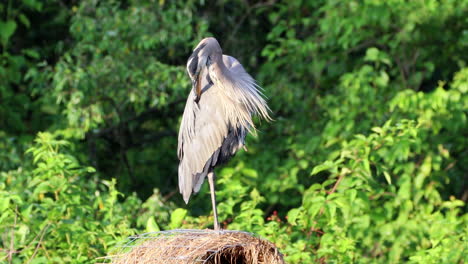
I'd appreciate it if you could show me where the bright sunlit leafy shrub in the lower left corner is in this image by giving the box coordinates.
[0,132,141,263]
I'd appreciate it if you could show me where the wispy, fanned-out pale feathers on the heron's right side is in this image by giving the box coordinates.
[210,56,272,132]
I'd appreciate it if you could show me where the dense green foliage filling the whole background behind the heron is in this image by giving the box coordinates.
[0,0,468,263]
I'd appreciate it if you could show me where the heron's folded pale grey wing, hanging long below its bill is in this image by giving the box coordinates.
[178,69,229,202]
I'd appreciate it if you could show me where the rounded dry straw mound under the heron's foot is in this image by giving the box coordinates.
[106,230,284,264]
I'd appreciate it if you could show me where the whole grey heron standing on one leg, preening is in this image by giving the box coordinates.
[177,38,271,230]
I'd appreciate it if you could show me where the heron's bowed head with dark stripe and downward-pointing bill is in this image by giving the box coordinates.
[187,37,223,97]
